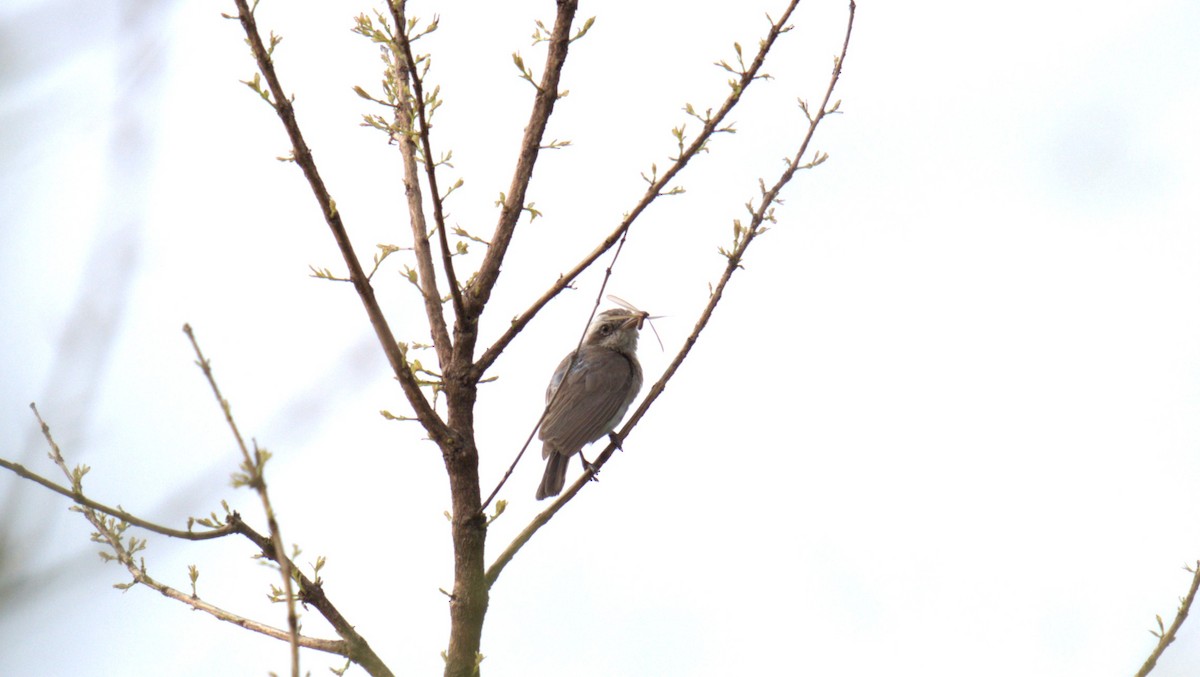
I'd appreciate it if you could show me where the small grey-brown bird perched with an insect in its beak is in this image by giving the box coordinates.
[538,308,648,501]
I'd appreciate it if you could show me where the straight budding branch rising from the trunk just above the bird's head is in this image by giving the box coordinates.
[472,0,799,379]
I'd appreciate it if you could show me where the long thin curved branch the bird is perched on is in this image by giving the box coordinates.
[486,0,856,586]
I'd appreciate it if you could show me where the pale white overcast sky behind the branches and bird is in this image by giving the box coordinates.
[0,0,1200,677]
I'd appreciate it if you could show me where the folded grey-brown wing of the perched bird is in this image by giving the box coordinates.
[538,346,636,456]
